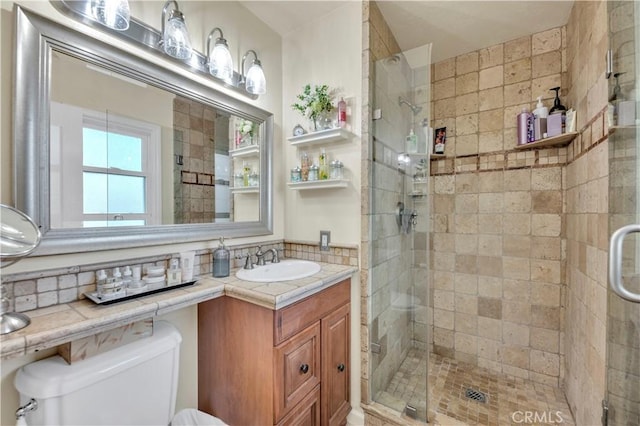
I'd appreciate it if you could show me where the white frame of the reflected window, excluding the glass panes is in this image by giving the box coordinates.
[49,102,162,228]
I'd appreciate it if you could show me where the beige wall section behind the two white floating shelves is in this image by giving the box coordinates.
[282,2,362,248]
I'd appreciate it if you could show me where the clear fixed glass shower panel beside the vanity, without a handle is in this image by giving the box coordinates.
[368,46,430,421]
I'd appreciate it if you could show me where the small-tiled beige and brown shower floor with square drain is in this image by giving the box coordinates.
[377,349,575,426]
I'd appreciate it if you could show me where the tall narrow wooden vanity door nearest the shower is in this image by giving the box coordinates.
[321,304,351,426]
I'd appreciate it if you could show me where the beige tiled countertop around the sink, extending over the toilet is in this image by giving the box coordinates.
[0,262,357,359]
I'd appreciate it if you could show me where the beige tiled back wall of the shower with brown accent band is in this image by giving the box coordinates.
[431,28,567,385]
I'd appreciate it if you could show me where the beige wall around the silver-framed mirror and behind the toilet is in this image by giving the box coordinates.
[0,1,284,424]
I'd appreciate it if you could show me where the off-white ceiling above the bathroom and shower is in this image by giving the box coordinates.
[241,0,573,62]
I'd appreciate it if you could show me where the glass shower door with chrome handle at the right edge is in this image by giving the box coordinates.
[603,1,640,425]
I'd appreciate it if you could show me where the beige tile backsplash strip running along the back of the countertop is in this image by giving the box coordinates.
[2,240,358,312]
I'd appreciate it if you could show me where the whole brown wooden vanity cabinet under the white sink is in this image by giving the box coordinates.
[198,280,351,426]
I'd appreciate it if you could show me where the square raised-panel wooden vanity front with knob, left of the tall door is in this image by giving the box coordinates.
[274,321,320,423]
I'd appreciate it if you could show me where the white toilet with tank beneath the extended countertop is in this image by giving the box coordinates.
[15,321,225,426]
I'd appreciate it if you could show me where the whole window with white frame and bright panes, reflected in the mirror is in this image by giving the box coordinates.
[51,104,161,227]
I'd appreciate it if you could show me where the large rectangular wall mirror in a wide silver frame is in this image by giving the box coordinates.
[14,7,273,254]
